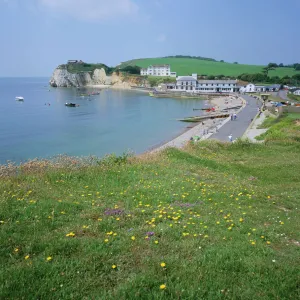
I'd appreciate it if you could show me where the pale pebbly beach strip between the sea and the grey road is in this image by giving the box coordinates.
[149,96,245,152]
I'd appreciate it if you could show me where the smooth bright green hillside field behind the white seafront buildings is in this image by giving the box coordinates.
[121,58,300,77]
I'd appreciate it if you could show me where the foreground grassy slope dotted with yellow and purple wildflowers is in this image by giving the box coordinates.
[0,115,300,299]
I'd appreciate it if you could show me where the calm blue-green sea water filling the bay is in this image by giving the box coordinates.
[0,78,205,164]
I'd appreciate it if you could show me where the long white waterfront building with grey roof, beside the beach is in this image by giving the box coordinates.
[169,74,239,93]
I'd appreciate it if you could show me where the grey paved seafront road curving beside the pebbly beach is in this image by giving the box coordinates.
[210,95,261,142]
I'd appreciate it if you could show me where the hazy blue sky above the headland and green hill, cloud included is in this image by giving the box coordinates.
[0,0,300,77]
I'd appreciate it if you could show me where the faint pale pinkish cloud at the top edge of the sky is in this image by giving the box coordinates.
[38,0,138,21]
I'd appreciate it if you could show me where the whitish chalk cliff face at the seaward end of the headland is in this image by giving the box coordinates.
[49,66,109,87]
